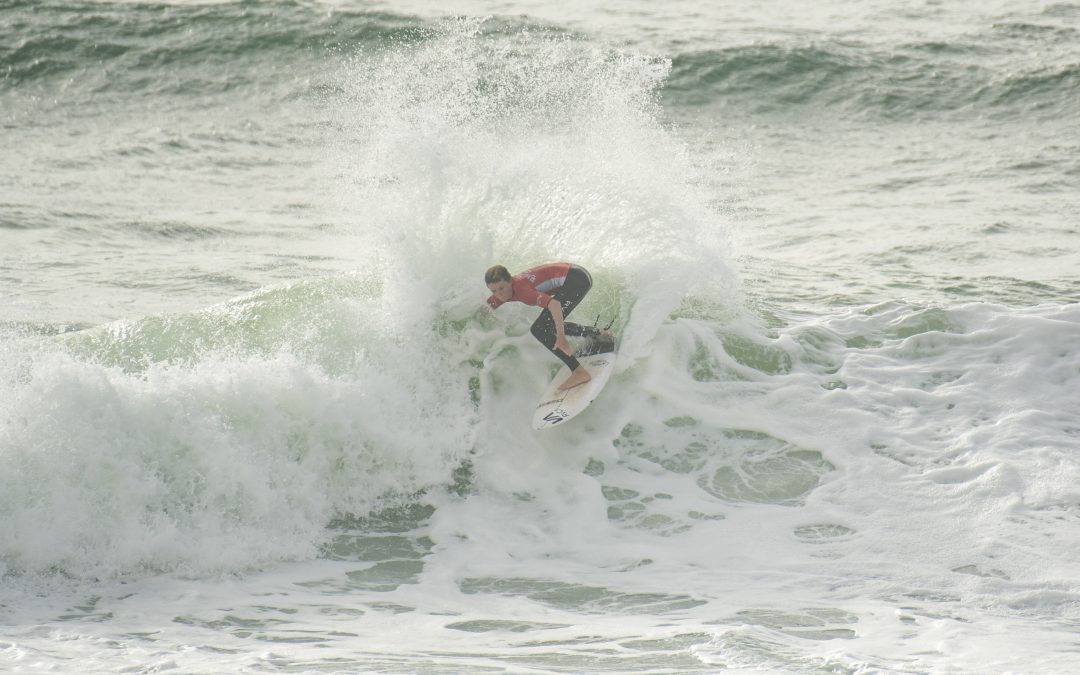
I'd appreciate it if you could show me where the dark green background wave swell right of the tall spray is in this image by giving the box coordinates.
[666,24,1080,121]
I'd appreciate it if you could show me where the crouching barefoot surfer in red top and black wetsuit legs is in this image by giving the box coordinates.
[484,262,600,390]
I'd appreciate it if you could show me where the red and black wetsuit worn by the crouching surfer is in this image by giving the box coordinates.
[487,262,598,370]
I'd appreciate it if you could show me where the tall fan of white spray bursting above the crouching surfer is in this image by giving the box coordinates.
[327,19,733,354]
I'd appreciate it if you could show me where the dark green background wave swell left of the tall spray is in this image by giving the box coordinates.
[0,2,397,89]
